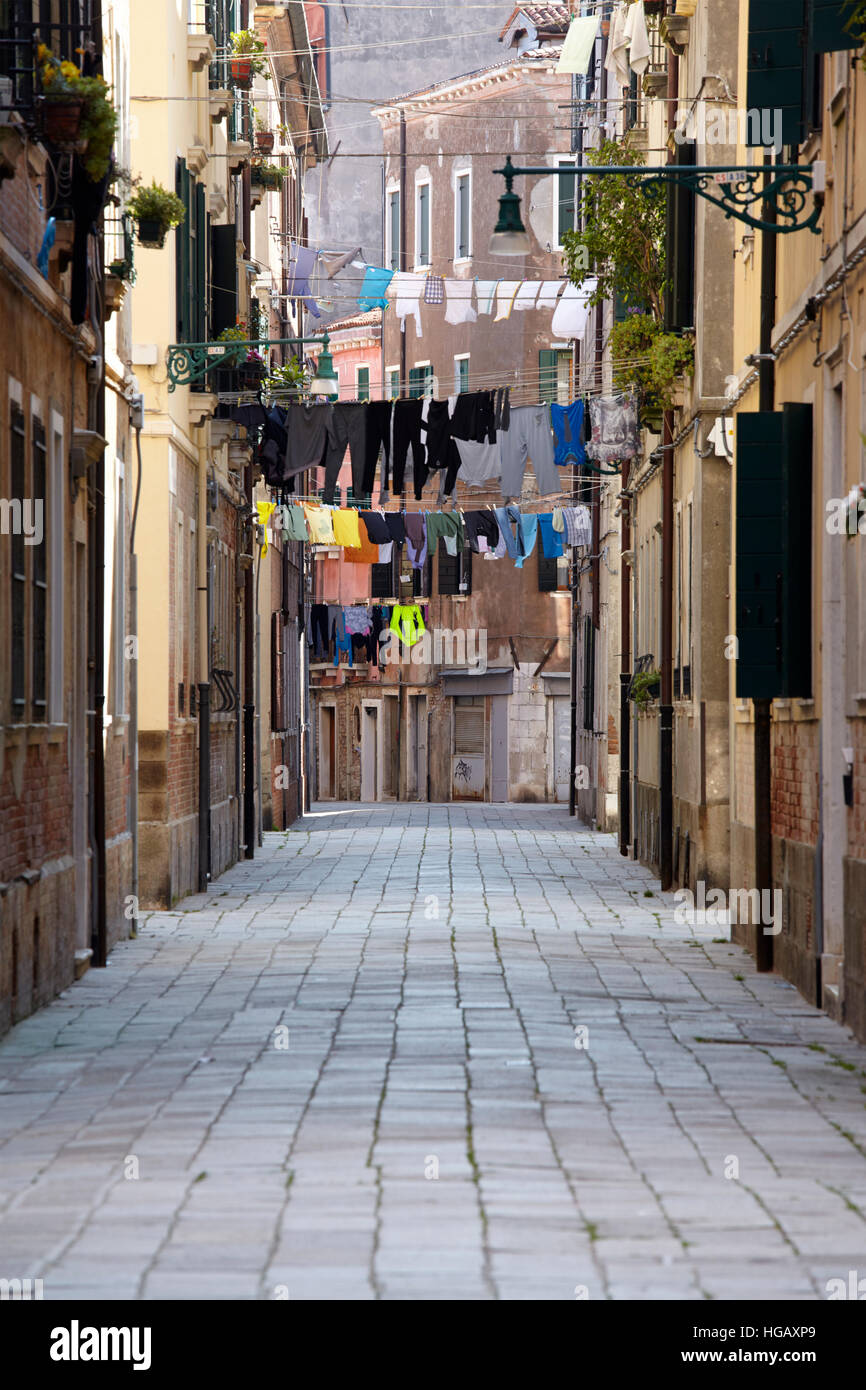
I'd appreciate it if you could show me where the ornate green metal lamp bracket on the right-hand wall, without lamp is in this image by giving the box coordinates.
[495,157,824,234]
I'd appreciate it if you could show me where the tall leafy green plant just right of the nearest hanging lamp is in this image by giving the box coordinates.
[563,140,666,322]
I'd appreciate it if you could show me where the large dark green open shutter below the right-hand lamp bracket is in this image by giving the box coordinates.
[737,403,812,699]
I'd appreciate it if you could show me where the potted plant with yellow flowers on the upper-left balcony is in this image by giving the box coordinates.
[36,43,117,183]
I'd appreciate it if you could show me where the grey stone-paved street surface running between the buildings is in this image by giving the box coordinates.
[0,803,866,1300]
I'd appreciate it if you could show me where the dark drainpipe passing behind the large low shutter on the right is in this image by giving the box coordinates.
[753,154,777,970]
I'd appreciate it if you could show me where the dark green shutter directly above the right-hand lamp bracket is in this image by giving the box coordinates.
[745,0,806,145]
